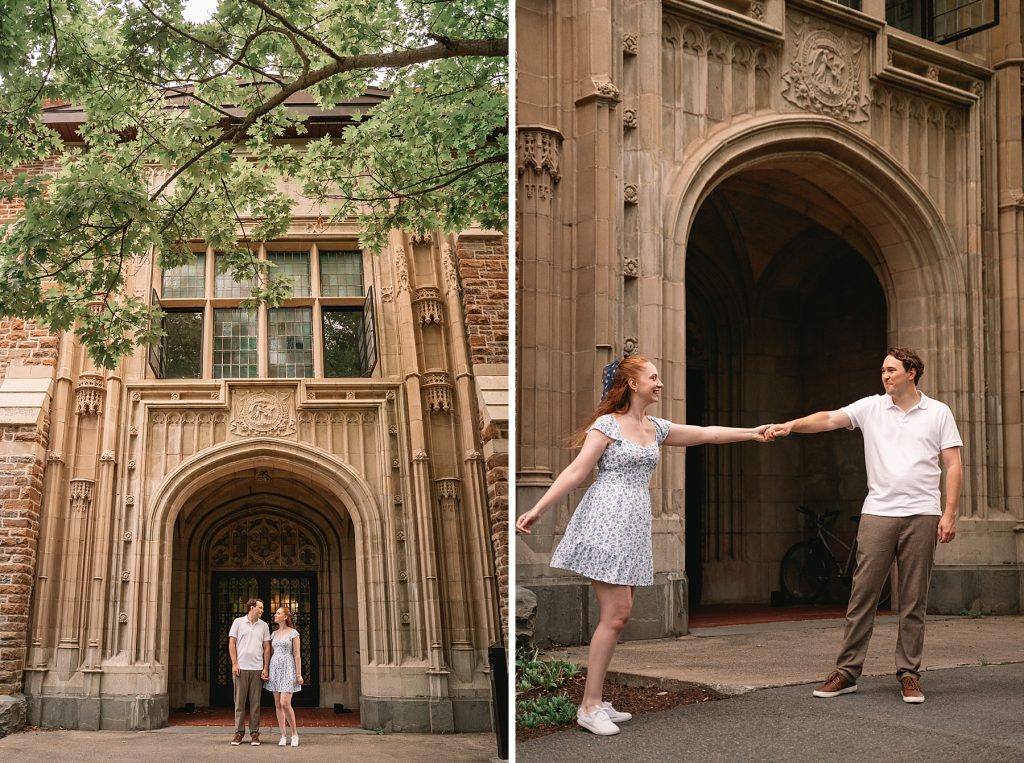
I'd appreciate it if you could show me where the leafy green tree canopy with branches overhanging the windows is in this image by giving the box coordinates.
[0,0,508,368]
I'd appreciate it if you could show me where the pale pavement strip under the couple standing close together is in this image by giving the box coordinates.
[0,726,498,763]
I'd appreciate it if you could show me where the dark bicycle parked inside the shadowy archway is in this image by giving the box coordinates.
[779,506,892,608]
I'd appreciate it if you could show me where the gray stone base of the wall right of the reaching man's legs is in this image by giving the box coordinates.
[928,565,1022,614]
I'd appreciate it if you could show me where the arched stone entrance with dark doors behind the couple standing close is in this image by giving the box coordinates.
[149,442,373,709]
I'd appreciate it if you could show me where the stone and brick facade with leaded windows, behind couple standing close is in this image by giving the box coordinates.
[0,107,508,732]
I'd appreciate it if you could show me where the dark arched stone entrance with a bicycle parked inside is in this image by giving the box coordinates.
[666,115,973,606]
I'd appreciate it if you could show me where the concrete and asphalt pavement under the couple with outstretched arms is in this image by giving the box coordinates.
[515,617,1024,763]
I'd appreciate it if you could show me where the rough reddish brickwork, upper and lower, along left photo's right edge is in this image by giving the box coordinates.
[457,236,509,635]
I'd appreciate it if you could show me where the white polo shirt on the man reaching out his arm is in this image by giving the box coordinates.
[842,390,964,516]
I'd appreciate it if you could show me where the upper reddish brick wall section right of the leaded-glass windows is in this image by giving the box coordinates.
[458,236,509,364]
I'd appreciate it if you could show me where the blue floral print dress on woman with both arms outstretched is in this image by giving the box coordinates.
[551,414,672,586]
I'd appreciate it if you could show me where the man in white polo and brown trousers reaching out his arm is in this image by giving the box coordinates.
[771,347,964,704]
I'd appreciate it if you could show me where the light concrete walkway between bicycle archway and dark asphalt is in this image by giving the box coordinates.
[545,617,1024,694]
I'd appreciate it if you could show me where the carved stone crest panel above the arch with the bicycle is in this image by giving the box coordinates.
[782,15,868,123]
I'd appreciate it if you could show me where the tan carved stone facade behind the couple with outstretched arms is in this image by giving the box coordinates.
[516,0,1024,643]
